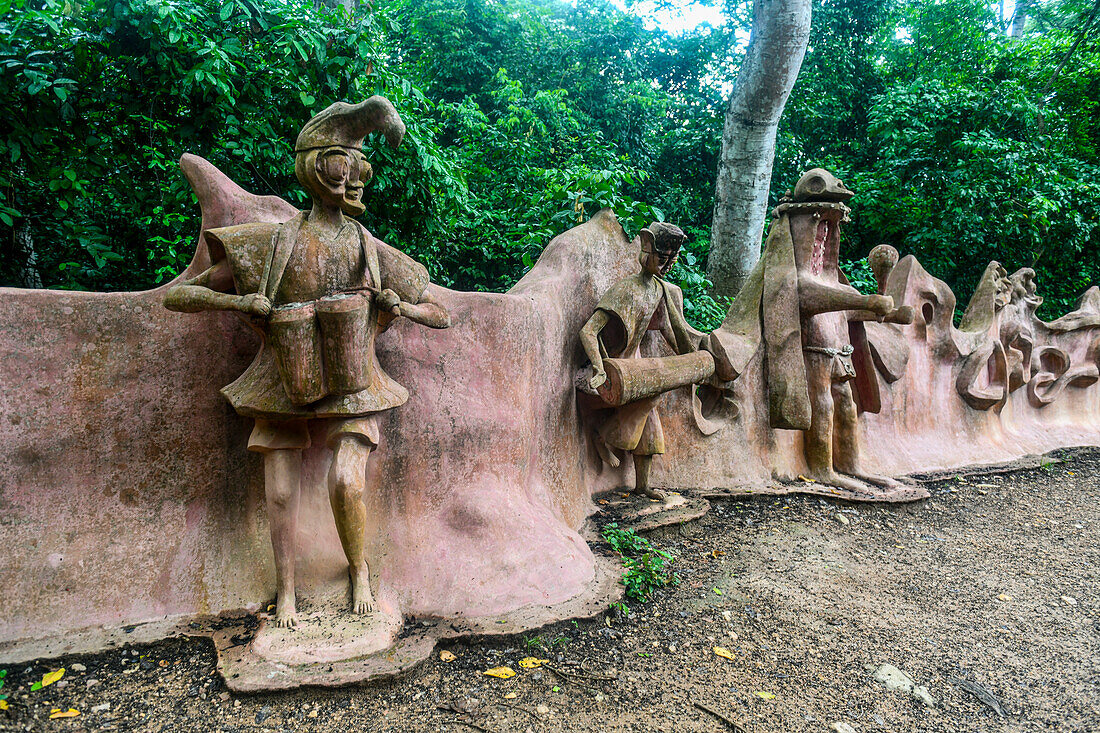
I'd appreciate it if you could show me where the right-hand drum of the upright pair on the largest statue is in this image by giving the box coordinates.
[316,293,375,394]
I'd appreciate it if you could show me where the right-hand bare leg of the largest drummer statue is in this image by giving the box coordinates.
[329,435,374,613]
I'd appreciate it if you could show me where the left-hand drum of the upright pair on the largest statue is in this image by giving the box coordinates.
[267,303,327,405]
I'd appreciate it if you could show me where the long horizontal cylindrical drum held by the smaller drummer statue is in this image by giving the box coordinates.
[598,351,714,407]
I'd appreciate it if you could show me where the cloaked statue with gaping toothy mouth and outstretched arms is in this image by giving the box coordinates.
[711,168,913,497]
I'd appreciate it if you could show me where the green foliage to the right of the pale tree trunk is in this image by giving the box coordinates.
[773,0,1100,318]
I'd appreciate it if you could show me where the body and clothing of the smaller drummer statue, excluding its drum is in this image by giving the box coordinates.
[581,222,699,500]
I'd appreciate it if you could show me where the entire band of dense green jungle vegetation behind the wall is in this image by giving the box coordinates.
[0,0,1100,325]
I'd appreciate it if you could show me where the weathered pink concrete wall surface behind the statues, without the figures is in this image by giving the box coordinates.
[0,176,1100,658]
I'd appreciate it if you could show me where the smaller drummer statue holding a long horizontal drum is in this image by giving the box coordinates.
[578,222,719,501]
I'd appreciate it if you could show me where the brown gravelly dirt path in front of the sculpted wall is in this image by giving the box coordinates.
[0,451,1100,733]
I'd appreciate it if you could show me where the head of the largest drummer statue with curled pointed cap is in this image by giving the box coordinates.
[294,96,405,217]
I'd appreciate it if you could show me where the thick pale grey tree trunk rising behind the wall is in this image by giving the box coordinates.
[707,0,811,296]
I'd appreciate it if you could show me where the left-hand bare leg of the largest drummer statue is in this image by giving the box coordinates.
[264,450,301,627]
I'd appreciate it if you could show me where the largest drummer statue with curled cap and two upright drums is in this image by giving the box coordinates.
[165,96,450,626]
